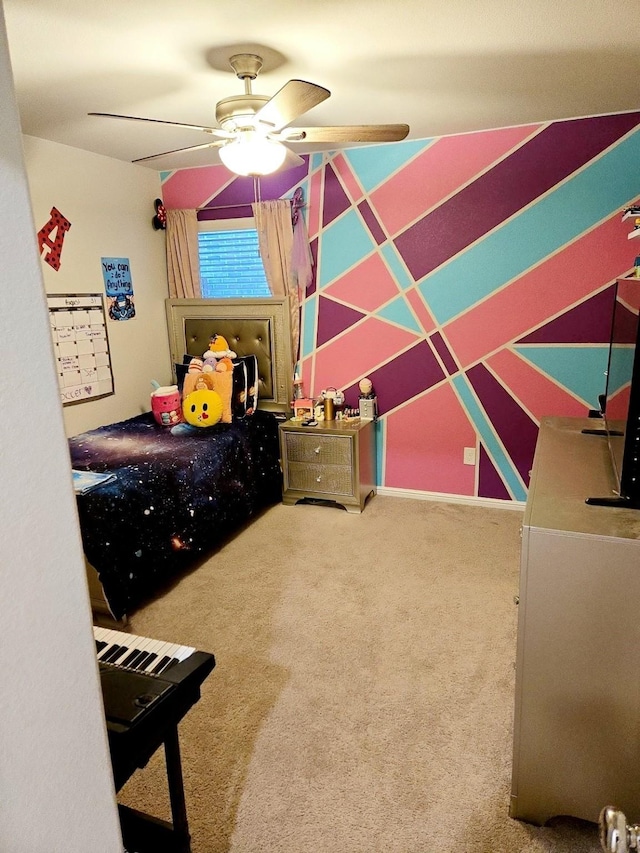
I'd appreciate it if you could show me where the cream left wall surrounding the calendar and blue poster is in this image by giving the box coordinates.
[22,137,171,435]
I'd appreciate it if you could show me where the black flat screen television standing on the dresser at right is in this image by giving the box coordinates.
[587,279,640,509]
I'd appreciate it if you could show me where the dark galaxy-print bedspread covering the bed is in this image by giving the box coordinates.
[69,411,282,619]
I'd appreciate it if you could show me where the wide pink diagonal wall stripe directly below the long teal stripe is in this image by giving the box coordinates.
[444,213,631,367]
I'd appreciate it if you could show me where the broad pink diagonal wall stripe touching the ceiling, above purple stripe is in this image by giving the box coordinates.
[370,124,543,236]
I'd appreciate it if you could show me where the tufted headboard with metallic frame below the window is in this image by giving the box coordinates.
[166,299,294,414]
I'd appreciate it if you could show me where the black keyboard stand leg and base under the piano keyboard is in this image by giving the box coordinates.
[118,725,191,853]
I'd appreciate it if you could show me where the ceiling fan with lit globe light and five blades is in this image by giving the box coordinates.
[89,53,409,176]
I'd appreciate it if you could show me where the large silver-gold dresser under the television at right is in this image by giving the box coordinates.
[510,418,640,824]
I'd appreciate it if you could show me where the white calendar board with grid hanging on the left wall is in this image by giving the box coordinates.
[47,293,114,406]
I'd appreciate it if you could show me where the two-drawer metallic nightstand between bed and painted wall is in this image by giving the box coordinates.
[280,420,376,512]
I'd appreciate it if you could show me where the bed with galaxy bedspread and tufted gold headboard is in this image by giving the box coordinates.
[74,299,293,622]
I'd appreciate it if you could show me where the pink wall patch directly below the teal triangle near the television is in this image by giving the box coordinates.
[487,350,585,423]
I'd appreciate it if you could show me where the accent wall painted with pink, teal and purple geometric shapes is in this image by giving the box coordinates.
[163,113,640,501]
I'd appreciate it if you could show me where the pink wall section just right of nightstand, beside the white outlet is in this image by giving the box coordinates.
[384,383,476,496]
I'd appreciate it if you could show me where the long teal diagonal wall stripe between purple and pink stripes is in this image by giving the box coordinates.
[419,131,640,323]
